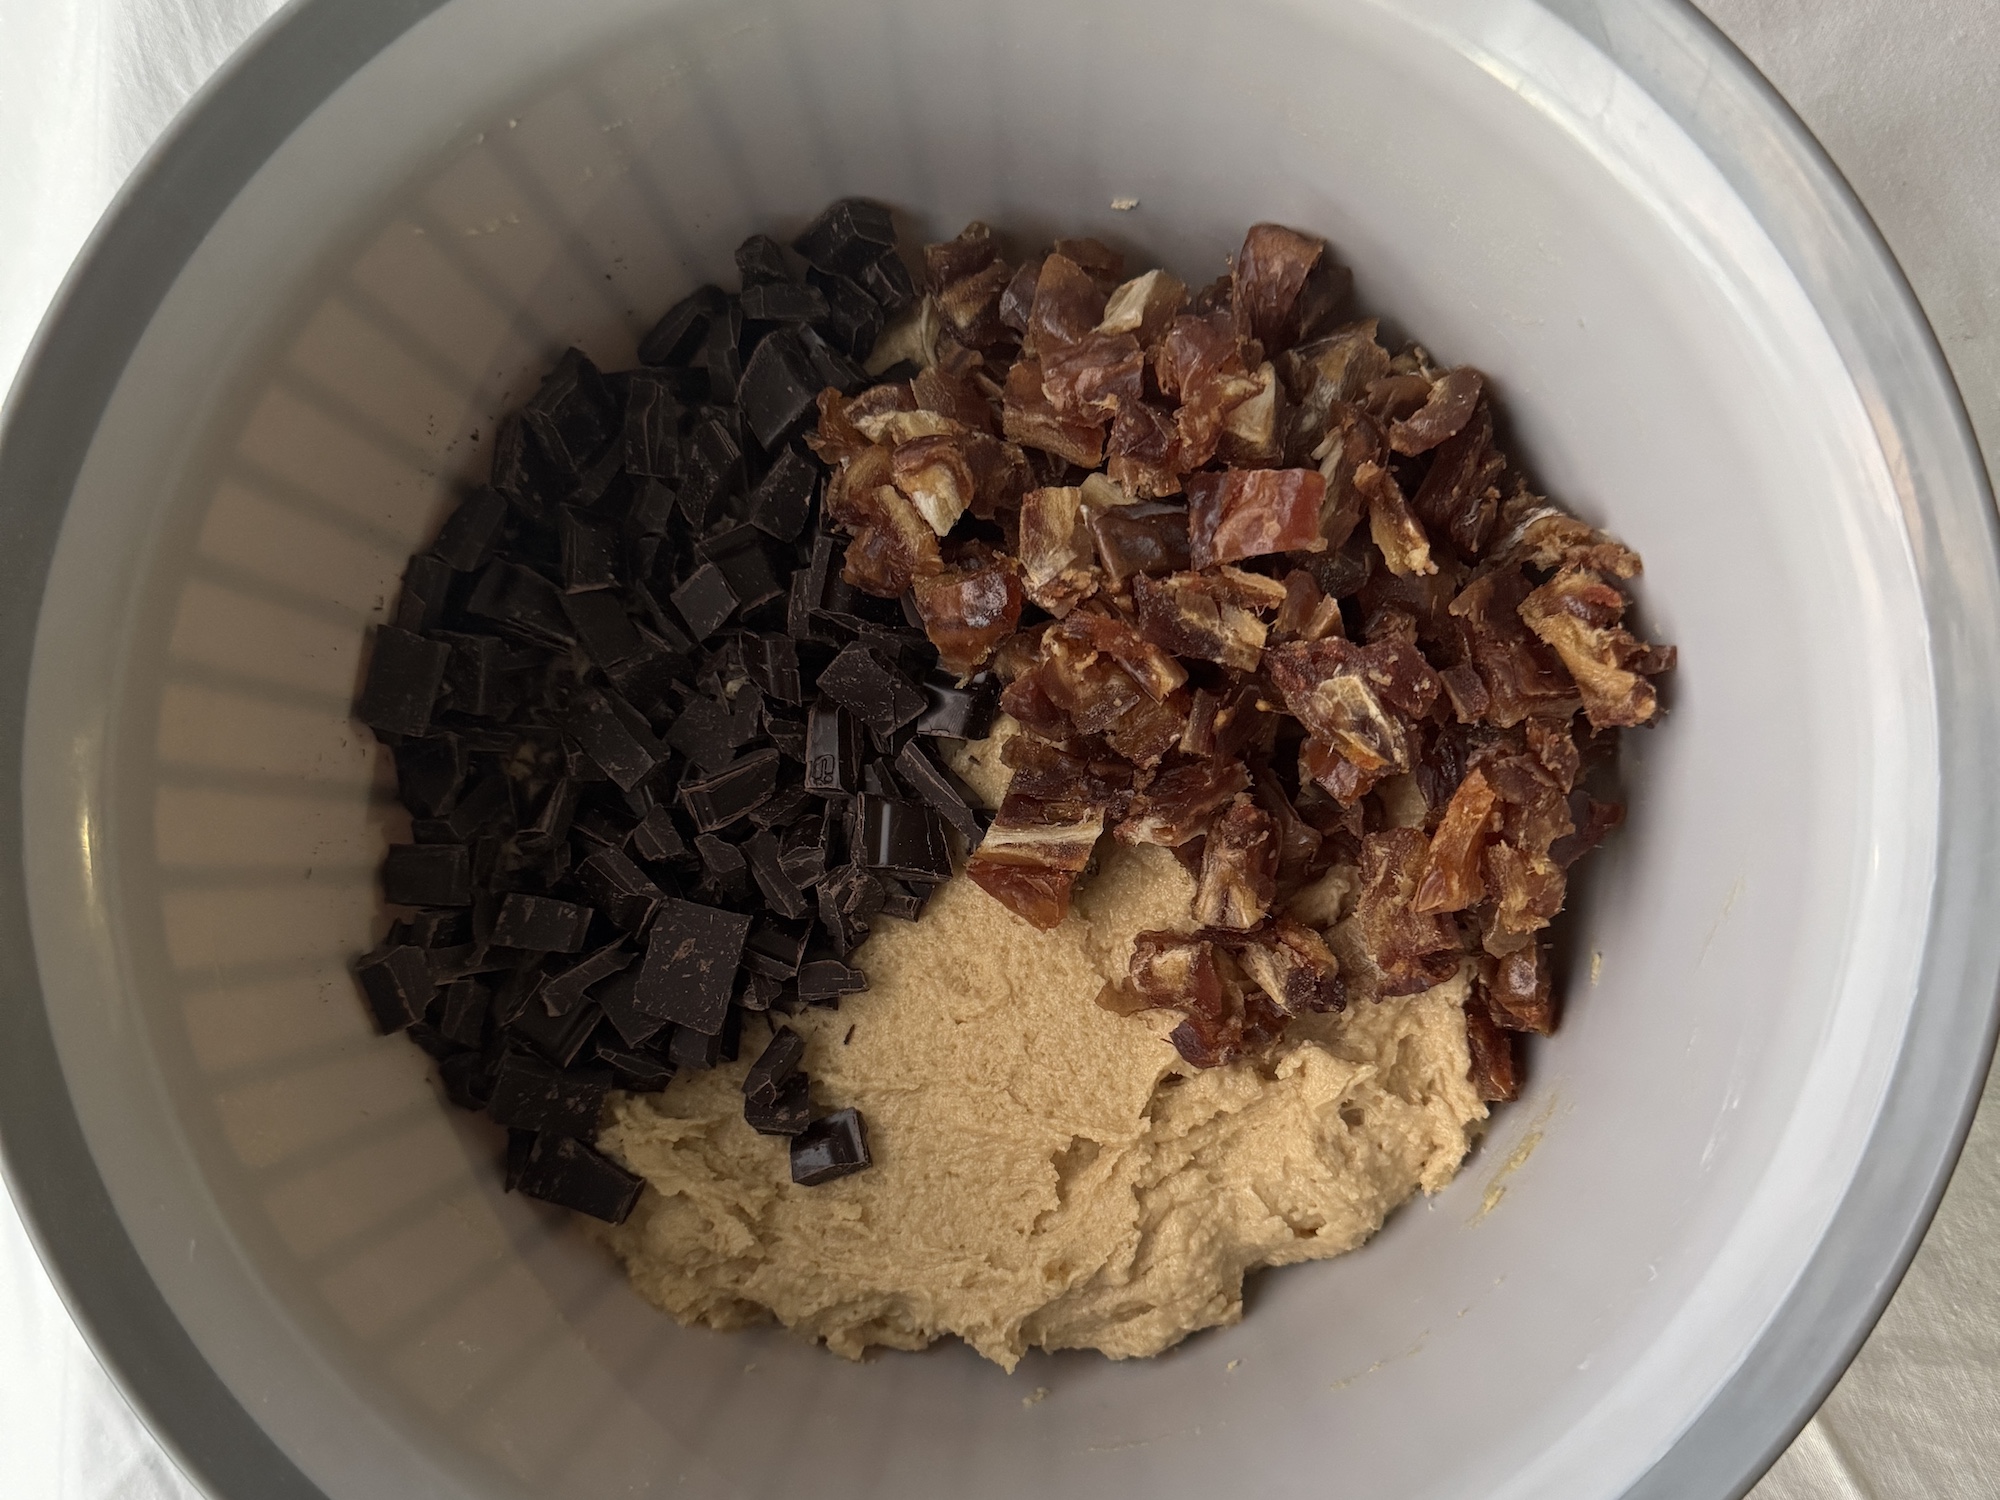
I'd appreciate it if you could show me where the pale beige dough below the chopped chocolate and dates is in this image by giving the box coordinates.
[598,728,1486,1368]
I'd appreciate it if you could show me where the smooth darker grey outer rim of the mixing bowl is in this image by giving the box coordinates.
[0,0,2000,1500]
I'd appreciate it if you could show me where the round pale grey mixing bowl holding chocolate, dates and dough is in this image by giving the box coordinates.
[0,0,2000,1500]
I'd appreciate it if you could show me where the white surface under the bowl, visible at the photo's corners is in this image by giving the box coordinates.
[0,0,2000,1500]
